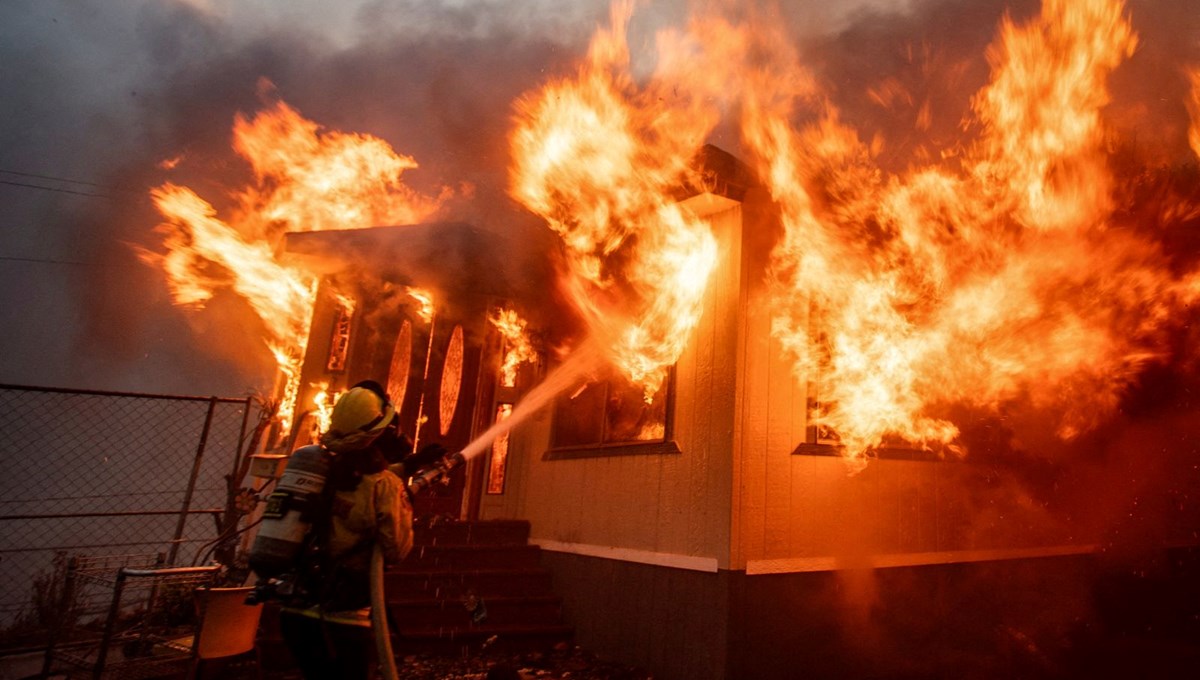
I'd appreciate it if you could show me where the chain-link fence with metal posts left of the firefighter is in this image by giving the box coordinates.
[0,385,254,648]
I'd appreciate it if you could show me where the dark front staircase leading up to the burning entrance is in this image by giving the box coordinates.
[385,520,574,656]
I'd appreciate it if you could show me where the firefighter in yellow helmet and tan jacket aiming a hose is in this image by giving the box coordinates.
[280,380,412,680]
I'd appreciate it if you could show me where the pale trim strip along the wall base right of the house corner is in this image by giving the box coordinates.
[746,543,1099,576]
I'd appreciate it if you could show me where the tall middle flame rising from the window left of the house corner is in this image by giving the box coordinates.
[511,2,716,395]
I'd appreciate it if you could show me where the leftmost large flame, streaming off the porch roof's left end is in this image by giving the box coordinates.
[142,93,450,431]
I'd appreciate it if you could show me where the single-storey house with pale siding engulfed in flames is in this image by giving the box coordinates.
[145,0,1200,678]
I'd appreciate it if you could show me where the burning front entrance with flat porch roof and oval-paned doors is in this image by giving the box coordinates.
[281,222,548,518]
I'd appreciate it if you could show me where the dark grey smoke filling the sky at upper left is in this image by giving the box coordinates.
[0,0,604,393]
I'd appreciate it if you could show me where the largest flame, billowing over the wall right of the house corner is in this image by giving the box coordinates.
[676,0,1194,462]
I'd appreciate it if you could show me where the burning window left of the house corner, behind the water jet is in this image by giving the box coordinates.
[553,364,673,447]
